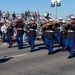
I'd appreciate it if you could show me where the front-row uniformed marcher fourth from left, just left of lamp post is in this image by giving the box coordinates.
[45,19,54,55]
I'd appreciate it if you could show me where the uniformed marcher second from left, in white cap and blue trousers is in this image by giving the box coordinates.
[16,17,24,49]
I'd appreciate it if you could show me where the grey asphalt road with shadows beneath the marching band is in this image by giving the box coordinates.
[0,41,75,75]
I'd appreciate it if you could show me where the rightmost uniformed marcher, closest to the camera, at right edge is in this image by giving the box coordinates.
[66,16,75,58]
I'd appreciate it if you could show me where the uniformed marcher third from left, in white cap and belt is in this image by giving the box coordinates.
[28,18,37,52]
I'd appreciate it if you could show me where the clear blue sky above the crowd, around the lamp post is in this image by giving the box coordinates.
[0,0,75,18]
